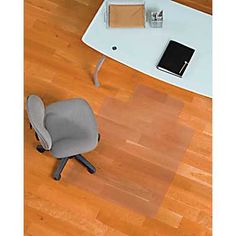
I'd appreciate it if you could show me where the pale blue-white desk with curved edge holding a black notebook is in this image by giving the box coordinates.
[82,0,212,97]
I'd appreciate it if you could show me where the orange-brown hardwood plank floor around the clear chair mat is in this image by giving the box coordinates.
[25,0,212,236]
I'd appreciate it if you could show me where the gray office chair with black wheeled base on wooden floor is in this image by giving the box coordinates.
[26,95,100,180]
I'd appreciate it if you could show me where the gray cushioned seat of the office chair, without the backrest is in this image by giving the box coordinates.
[45,99,98,158]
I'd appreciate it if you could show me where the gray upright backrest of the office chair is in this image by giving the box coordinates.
[26,95,52,150]
